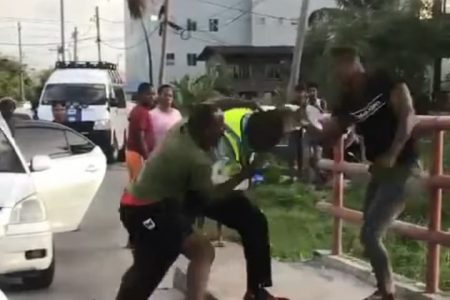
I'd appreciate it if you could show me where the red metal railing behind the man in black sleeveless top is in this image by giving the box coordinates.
[317,116,450,293]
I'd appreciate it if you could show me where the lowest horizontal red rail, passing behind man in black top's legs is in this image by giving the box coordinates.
[316,201,450,247]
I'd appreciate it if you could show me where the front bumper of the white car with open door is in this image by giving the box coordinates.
[0,224,54,275]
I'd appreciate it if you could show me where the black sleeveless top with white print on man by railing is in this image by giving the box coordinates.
[333,71,418,165]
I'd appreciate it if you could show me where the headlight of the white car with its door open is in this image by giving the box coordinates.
[9,196,47,225]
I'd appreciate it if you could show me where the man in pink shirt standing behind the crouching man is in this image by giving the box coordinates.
[150,84,182,146]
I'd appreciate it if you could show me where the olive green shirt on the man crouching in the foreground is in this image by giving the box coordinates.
[128,123,215,203]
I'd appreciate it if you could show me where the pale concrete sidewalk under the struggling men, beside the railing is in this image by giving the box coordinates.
[174,243,374,300]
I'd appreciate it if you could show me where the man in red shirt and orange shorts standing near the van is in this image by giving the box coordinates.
[121,83,156,248]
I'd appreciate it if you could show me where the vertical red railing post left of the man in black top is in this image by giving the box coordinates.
[332,137,344,255]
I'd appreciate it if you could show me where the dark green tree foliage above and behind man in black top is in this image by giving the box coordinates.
[303,0,450,104]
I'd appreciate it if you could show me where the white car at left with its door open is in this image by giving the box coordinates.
[0,121,106,288]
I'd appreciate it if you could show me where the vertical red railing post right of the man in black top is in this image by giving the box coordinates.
[426,131,444,293]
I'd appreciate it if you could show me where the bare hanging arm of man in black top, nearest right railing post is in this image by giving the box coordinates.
[388,83,417,159]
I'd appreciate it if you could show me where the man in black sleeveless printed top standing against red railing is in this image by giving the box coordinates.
[323,48,418,300]
